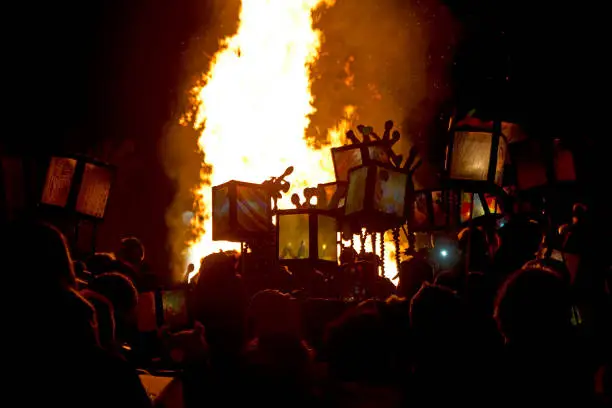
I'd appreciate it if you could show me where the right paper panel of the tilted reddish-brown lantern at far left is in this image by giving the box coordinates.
[76,163,113,219]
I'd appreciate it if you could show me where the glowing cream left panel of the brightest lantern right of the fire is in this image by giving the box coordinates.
[450,131,492,181]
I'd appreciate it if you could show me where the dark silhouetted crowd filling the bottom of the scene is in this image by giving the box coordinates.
[1,205,612,407]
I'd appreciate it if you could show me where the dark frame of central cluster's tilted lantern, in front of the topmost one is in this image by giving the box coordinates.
[343,163,414,232]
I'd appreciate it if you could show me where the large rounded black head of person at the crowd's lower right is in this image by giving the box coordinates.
[495,266,571,344]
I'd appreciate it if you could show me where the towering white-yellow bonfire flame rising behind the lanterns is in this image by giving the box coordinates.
[188,0,395,278]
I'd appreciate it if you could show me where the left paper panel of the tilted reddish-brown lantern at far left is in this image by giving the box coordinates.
[41,157,77,207]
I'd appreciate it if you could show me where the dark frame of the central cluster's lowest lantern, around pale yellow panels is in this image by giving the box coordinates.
[275,207,339,269]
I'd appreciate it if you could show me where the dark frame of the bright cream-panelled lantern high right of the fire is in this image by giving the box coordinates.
[444,122,508,194]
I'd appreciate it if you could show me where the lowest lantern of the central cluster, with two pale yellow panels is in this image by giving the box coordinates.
[276,208,338,265]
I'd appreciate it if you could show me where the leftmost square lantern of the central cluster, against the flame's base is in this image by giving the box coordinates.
[212,180,274,242]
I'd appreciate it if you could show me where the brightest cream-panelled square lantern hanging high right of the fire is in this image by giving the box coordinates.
[445,128,508,189]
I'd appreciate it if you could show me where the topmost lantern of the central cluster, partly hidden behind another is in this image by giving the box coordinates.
[331,142,391,182]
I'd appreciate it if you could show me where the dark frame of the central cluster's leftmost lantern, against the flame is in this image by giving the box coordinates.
[212,180,274,242]
